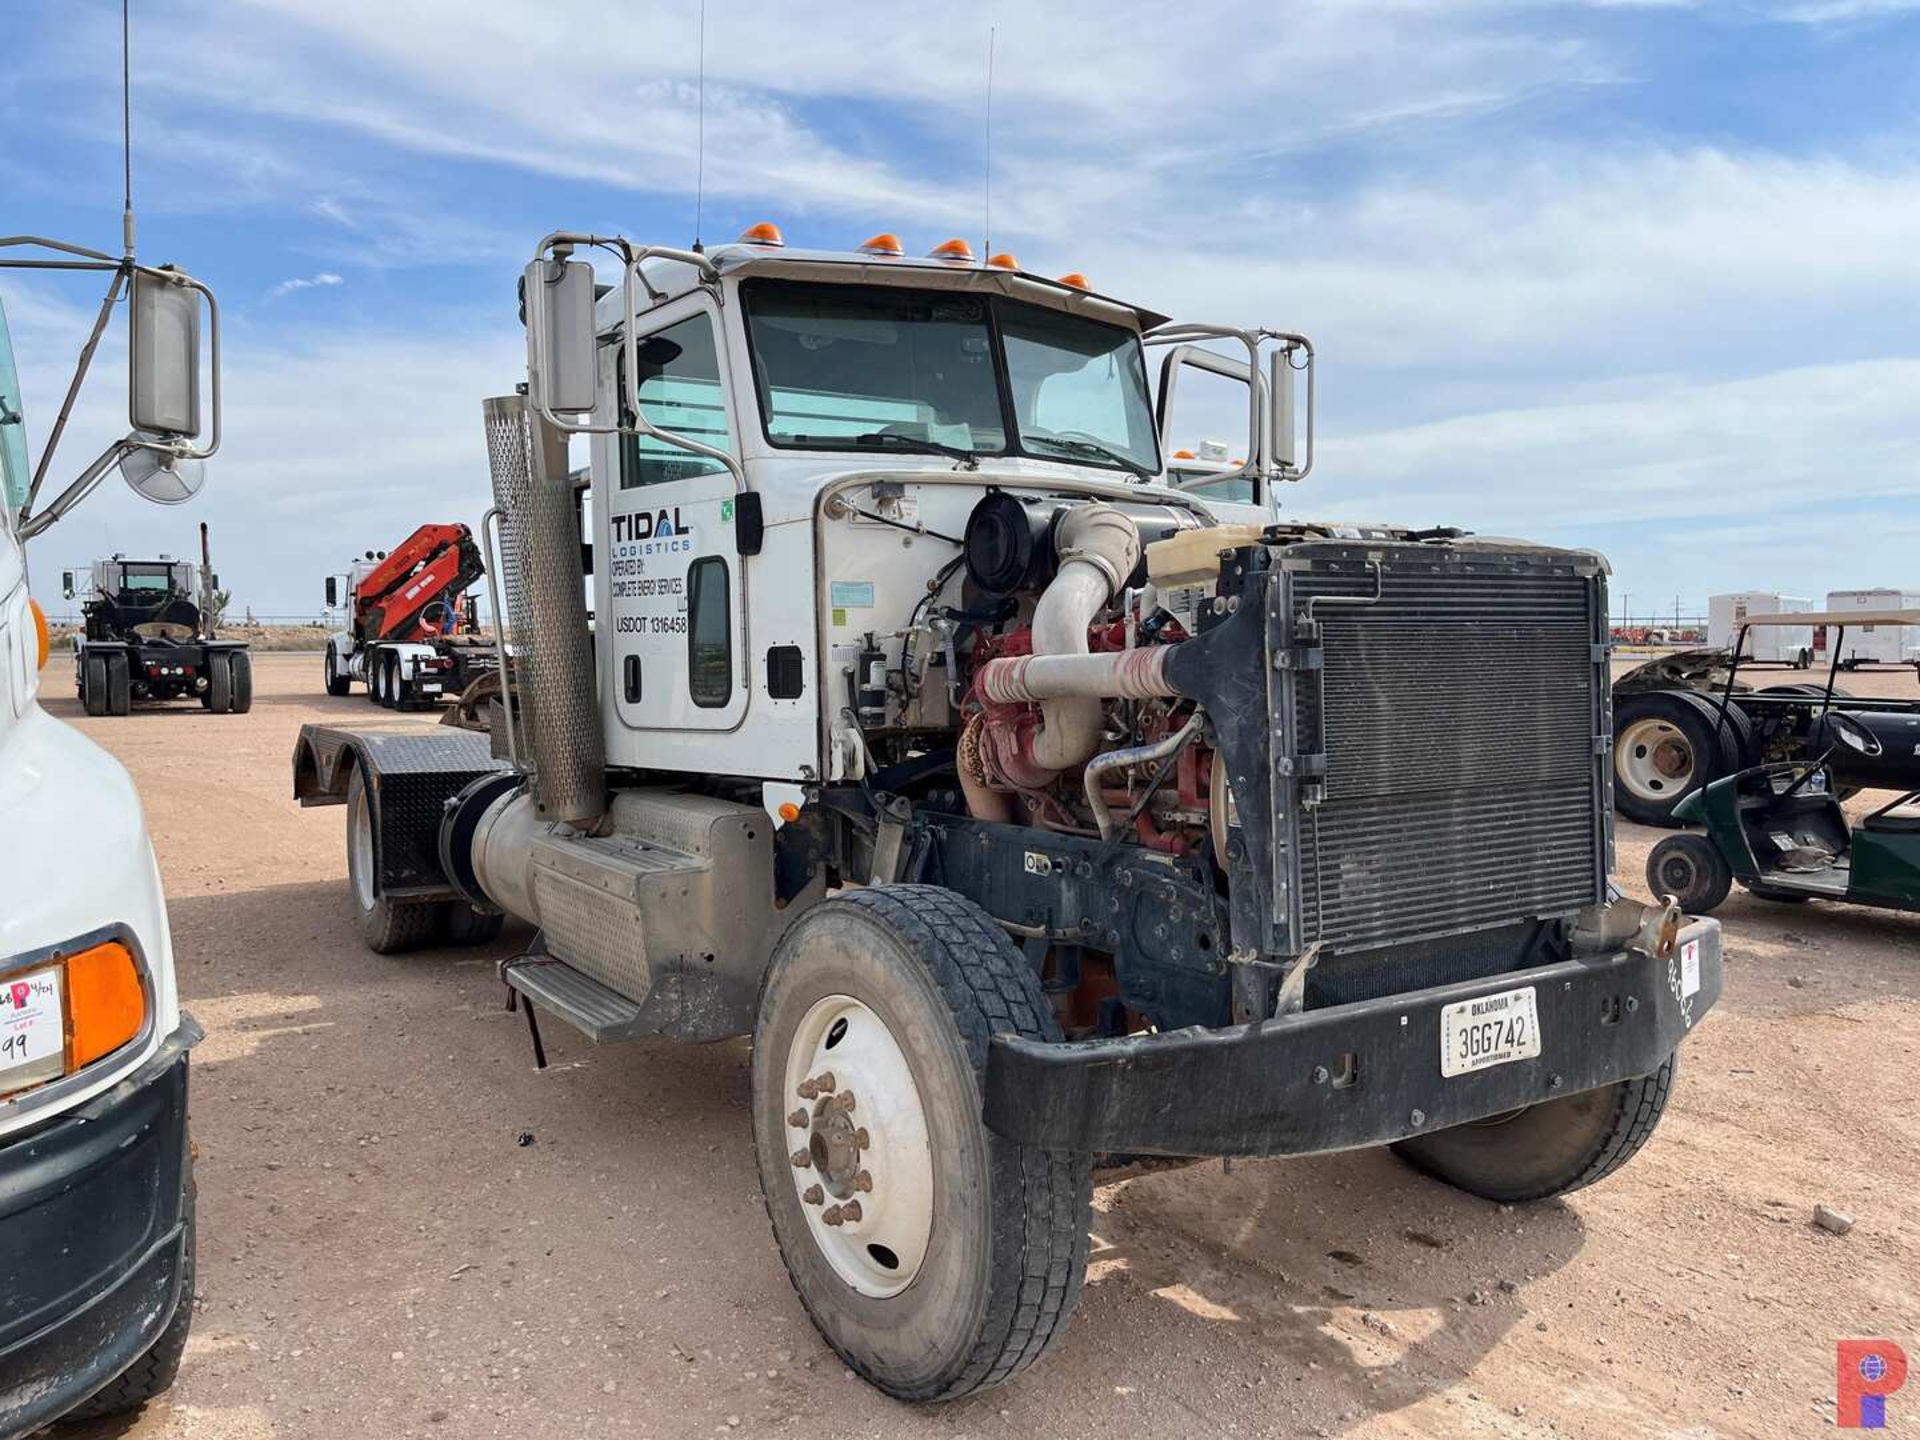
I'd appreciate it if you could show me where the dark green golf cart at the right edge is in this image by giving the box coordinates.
[1647,611,1920,914]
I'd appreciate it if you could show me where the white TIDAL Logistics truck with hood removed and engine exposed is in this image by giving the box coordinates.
[294,227,1720,1402]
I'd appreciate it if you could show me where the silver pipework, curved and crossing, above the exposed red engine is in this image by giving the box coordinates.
[981,501,1136,774]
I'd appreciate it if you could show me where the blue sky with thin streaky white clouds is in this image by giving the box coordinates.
[0,0,1920,614]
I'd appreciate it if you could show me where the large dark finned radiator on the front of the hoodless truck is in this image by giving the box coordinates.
[1277,545,1609,952]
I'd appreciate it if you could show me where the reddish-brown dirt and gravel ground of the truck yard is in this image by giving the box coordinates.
[48,655,1920,1440]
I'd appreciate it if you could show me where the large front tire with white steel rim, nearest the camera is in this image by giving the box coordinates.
[753,885,1092,1402]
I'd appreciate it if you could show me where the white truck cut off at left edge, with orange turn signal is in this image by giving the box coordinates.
[0,225,219,1436]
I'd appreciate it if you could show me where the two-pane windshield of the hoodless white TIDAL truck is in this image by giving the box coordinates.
[741,278,1160,474]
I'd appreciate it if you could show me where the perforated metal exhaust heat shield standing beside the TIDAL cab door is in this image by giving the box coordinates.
[482,396,607,826]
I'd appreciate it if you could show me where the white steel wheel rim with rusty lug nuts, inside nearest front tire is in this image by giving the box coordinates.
[785,995,933,1296]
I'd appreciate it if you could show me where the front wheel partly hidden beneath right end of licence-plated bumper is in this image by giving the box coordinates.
[1392,1056,1676,1204]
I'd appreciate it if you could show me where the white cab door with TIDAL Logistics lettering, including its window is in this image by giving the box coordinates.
[595,296,749,730]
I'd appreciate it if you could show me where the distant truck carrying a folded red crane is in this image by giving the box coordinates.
[324,524,497,710]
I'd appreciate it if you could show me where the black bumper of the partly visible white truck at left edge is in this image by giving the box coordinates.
[0,1016,200,1440]
